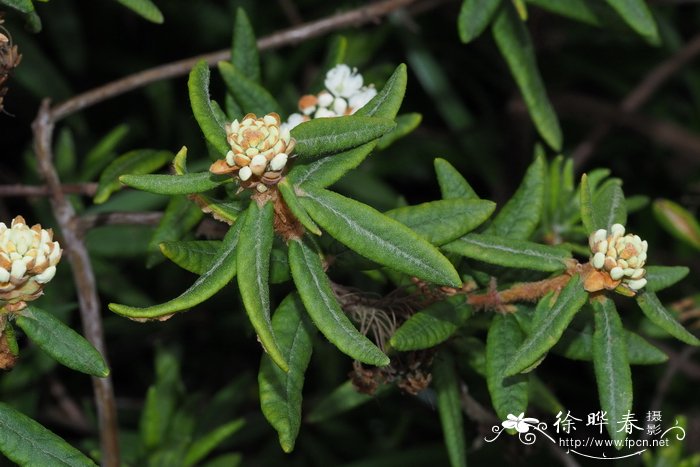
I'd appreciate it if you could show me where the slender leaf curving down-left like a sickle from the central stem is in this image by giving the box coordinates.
[109,214,245,319]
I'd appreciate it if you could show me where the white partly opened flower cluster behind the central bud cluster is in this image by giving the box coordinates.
[282,64,377,130]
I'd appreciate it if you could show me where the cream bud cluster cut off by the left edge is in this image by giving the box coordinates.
[0,216,62,311]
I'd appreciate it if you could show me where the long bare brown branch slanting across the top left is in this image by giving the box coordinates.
[50,0,416,122]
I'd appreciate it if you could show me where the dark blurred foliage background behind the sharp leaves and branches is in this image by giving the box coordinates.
[0,0,700,466]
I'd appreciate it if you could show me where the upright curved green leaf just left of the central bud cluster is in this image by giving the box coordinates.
[187,60,231,158]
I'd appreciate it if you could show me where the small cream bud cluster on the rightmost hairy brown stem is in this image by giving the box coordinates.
[588,224,648,292]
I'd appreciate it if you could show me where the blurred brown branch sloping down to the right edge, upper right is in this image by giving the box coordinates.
[552,95,700,164]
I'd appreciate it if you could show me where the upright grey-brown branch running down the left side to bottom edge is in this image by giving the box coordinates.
[32,100,120,467]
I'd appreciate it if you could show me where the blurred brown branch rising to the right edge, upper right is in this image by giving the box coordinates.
[571,35,700,169]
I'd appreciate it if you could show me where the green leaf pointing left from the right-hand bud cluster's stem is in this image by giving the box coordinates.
[442,233,571,272]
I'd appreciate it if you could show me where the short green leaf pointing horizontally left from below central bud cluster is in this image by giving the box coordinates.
[119,172,233,195]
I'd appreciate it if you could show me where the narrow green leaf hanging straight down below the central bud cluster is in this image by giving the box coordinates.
[236,201,289,371]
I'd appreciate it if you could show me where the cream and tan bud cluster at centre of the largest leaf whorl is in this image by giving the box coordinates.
[209,112,296,193]
